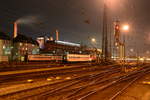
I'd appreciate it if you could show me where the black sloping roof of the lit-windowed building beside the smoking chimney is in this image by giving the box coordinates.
[13,34,38,45]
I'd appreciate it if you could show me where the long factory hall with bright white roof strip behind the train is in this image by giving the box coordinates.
[37,36,101,55]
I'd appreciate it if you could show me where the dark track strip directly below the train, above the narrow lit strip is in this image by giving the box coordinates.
[0,62,95,72]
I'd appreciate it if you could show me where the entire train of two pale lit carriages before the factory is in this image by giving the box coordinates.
[28,54,96,62]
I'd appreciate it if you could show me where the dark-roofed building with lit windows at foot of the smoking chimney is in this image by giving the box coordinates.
[12,34,39,61]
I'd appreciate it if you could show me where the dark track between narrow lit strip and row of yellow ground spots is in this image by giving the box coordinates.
[0,65,116,83]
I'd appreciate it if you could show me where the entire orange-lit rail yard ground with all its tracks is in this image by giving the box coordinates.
[0,63,150,100]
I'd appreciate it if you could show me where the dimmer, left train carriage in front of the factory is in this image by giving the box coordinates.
[28,54,63,61]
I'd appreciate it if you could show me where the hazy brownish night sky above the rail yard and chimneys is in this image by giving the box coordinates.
[0,0,150,54]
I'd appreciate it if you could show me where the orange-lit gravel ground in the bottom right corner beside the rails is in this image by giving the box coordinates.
[115,74,150,100]
